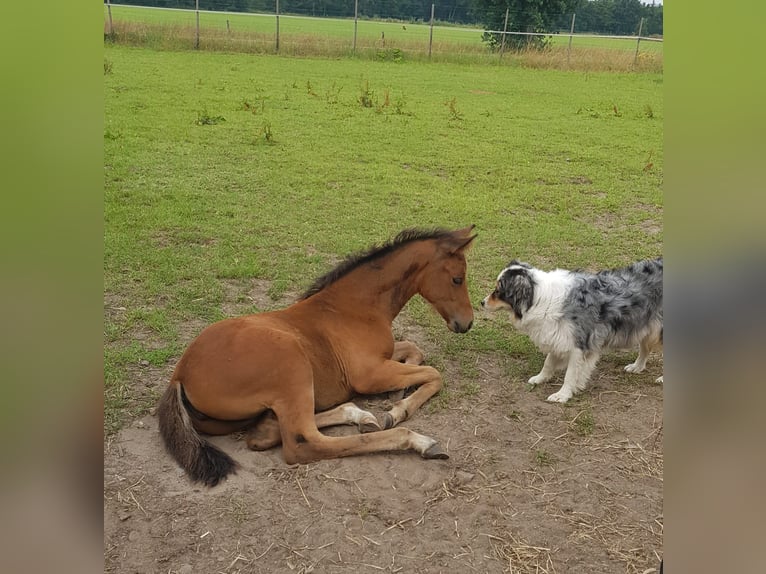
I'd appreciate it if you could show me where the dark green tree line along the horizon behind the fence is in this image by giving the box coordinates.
[111,0,663,41]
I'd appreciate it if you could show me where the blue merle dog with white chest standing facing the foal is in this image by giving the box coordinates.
[481,257,663,403]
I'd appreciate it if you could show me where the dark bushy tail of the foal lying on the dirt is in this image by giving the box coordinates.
[157,380,237,486]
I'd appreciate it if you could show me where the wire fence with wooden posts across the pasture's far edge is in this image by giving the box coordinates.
[104,0,662,69]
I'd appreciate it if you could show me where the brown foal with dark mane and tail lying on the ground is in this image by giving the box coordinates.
[157,226,476,486]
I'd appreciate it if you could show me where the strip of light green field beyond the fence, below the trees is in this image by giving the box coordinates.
[104,6,663,71]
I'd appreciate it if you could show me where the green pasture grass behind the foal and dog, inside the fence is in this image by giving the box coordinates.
[104,45,663,430]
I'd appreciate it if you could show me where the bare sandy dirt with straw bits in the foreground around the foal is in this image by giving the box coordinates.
[104,292,663,574]
